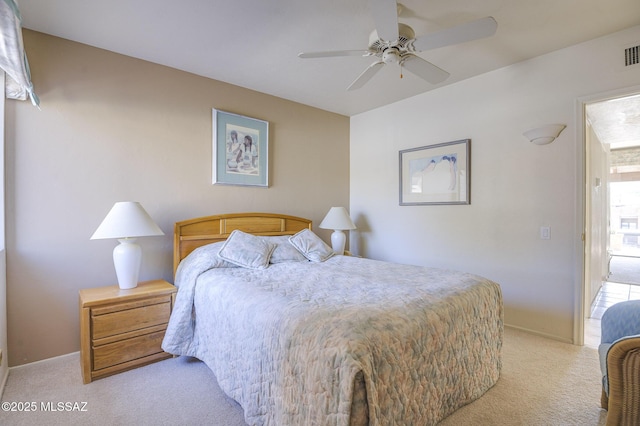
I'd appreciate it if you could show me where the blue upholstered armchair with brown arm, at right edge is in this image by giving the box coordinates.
[598,300,640,426]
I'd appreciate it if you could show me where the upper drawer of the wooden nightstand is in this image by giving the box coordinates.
[91,296,171,340]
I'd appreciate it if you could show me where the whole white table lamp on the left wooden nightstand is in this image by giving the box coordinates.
[91,201,164,290]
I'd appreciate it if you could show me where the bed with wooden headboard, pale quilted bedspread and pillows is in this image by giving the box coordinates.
[162,213,504,425]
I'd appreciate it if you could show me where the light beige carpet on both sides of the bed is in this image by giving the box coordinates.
[0,328,606,426]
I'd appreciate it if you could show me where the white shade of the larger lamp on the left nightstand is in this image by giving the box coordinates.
[91,201,164,240]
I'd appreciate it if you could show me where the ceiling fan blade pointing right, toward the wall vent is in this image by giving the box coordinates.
[413,16,498,52]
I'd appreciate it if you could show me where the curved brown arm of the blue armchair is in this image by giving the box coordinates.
[607,335,640,425]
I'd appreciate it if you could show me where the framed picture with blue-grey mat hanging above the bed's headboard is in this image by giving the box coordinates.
[212,109,269,187]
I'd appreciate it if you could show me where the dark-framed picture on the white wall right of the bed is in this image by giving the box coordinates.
[400,139,471,206]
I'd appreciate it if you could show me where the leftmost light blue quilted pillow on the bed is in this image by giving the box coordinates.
[218,229,275,269]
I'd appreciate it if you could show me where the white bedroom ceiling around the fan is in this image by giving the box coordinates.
[17,0,640,116]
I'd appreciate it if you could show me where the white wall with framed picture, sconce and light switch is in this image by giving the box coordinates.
[350,27,640,341]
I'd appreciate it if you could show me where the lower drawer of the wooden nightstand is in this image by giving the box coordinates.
[93,330,164,371]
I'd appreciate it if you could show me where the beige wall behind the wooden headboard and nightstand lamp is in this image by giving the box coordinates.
[6,31,349,365]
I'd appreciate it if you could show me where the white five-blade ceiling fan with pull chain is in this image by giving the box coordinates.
[298,0,498,90]
